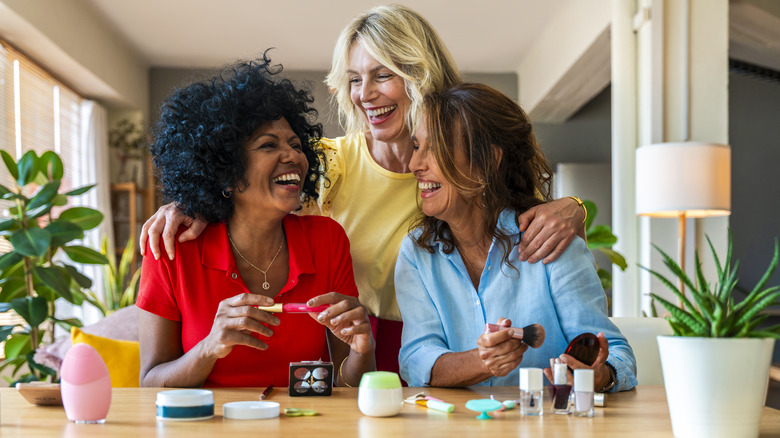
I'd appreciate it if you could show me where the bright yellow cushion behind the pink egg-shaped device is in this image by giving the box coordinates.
[70,327,141,388]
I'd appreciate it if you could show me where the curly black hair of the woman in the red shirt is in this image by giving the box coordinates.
[150,51,325,222]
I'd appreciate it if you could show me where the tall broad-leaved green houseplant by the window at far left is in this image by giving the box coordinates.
[0,151,108,381]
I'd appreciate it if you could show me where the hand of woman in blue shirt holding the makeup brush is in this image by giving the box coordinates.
[477,318,528,377]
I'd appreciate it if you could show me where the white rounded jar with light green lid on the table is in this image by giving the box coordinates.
[358,371,404,417]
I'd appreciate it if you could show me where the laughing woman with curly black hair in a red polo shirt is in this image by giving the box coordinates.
[137,56,375,387]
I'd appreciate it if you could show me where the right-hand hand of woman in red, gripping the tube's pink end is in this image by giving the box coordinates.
[306,292,376,354]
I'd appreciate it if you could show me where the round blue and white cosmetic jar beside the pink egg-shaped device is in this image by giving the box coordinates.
[155,389,214,421]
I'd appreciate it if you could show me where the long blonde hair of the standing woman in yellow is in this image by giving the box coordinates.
[325,5,462,134]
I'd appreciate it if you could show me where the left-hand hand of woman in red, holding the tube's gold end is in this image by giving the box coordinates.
[201,293,279,359]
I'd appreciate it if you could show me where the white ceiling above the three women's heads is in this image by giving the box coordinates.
[85,0,579,72]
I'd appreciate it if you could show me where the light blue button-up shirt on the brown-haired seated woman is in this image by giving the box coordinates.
[395,210,637,391]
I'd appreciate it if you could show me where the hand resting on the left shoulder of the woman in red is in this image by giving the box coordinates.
[138,203,208,260]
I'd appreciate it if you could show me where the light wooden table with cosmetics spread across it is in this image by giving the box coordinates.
[0,386,780,438]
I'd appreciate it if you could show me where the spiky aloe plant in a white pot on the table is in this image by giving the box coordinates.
[645,232,780,438]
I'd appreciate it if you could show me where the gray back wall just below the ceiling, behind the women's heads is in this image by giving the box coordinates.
[149,68,517,138]
